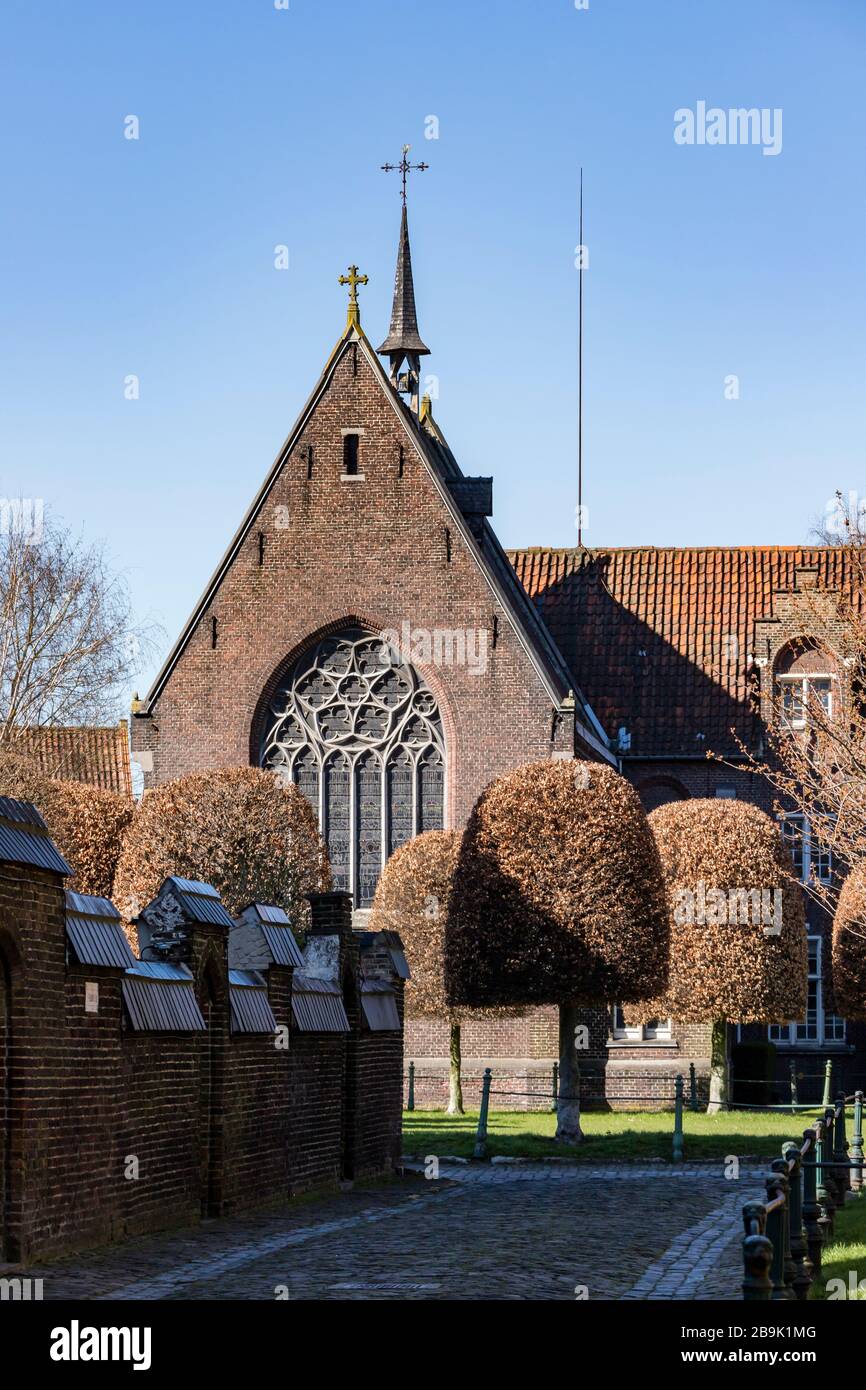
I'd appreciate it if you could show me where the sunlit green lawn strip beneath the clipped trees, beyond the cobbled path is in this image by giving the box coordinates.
[403,1111,810,1163]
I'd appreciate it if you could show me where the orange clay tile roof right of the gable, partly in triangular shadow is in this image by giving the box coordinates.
[509,546,848,758]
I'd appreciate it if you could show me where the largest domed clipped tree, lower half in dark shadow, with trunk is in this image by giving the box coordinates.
[445,762,669,1143]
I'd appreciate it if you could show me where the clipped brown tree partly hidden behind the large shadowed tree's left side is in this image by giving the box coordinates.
[370,830,518,1115]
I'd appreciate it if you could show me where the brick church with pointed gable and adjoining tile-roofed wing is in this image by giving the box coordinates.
[132,210,863,1104]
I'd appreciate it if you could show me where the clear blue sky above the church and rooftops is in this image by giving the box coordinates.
[0,0,866,687]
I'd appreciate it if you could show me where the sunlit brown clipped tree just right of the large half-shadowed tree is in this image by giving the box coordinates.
[636,798,808,1112]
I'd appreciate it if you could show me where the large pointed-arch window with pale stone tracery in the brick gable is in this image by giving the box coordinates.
[261,628,445,908]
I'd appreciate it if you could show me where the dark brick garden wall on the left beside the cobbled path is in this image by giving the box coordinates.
[0,863,402,1262]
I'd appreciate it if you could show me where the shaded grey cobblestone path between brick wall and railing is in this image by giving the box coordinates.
[20,1163,762,1302]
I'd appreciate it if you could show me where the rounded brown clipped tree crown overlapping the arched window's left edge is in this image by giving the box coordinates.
[113,767,331,931]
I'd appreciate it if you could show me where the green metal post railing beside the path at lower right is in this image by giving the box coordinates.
[742,1091,866,1301]
